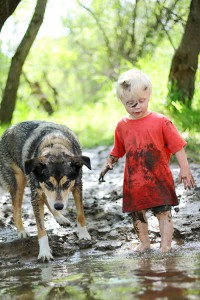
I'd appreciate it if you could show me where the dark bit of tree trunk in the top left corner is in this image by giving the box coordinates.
[0,0,21,31]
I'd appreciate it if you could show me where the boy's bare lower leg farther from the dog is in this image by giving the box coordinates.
[156,211,173,252]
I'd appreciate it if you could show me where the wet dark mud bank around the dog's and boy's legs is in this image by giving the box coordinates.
[0,147,200,267]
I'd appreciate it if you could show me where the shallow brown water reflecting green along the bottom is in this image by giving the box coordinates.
[0,242,200,300]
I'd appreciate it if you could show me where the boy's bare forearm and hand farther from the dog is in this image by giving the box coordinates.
[175,148,194,189]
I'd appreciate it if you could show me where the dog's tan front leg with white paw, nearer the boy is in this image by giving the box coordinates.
[72,187,91,240]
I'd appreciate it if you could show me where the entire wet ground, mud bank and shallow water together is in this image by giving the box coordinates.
[0,147,200,300]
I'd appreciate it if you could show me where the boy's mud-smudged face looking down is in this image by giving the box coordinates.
[121,91,150,120]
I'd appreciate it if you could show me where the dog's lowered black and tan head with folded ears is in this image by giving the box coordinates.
[25,153,91,210]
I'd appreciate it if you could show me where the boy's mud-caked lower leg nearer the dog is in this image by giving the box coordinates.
[132,210,150,252]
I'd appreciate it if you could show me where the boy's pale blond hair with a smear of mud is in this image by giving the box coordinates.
[116,69,152,100]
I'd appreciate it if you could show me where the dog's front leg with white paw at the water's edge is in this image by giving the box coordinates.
[31,192,53,261]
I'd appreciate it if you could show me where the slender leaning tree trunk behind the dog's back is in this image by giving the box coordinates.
[0,0,47,124]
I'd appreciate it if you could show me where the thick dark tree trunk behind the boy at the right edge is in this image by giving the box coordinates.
[168,0,200,107]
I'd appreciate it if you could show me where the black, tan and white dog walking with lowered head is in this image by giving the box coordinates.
[0,121,91,261]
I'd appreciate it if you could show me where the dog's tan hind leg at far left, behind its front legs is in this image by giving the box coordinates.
[10,165,29,238]
